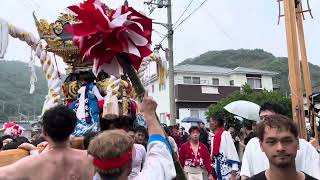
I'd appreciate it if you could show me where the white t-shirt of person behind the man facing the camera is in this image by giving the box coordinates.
[240,137,320,179]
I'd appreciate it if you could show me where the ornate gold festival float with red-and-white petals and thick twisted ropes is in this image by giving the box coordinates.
[0,0,182,174]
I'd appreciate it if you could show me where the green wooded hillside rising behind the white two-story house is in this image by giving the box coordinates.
[180,49,320,93]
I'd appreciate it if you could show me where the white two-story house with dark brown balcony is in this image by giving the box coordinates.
[145,64,277,124]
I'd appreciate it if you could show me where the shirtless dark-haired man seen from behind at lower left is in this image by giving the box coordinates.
[0,106,94,180]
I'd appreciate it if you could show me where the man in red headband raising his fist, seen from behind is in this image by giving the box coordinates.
[88,93,176,180]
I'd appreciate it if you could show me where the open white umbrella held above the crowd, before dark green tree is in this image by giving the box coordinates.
[224,100,260,121]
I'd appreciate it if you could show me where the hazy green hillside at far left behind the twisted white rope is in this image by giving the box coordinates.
[0,60,48,119]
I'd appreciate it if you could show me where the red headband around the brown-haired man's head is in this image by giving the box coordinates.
[93,149,132,170]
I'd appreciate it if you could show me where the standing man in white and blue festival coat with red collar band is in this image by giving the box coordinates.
[210,115,240,180]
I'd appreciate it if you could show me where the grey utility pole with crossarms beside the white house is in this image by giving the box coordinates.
[145,0,176,125]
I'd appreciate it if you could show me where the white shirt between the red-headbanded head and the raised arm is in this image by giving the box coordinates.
[128,144,147,180]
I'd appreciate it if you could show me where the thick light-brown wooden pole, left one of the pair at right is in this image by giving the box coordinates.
[284,0,307,139]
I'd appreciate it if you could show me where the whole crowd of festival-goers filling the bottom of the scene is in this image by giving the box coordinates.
[0,94,320,180]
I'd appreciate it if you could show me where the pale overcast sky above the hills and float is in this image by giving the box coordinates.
[0,0,320,71]
